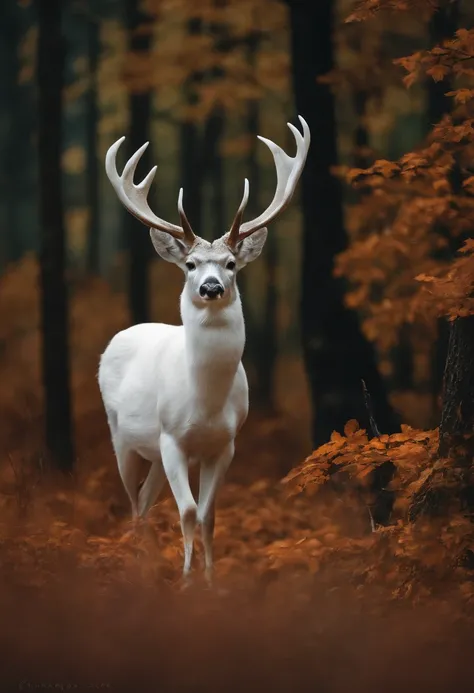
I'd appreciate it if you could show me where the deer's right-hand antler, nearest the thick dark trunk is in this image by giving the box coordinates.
[226,116,311,246]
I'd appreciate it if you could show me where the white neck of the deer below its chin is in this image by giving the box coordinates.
[181,294,245,413]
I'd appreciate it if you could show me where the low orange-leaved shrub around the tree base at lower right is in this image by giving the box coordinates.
[284,421,474,607]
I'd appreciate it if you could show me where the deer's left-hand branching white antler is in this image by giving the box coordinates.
[105,137,196,245]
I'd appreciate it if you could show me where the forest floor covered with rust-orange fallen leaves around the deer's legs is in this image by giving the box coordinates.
[0,408,474,693]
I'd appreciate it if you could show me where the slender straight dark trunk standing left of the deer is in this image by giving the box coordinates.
[37,0,74,470]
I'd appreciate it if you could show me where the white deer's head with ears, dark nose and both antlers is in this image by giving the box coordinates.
[105,116,310,305]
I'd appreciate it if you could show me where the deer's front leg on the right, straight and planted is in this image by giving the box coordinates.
[198,442,234,583]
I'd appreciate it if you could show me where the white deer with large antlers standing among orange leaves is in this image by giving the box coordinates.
[98,116,310,581]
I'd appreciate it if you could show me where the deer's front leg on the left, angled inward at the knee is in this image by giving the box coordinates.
[160,434,197,578]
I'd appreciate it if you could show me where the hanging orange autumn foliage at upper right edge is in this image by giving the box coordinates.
[337,8,474,374]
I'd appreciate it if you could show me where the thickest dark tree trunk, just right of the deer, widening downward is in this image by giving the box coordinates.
[288,0,399,445]
